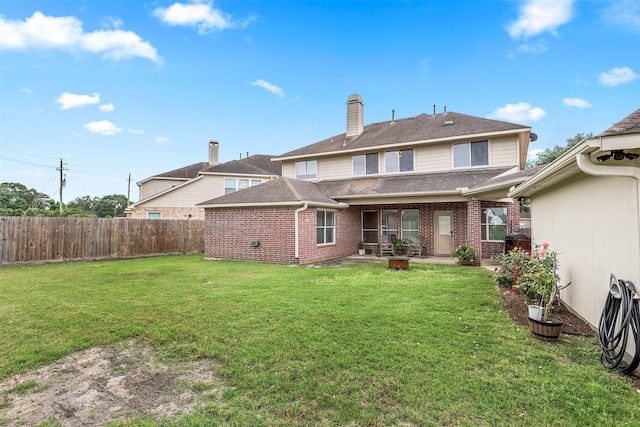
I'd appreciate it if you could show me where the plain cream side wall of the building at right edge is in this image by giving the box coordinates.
[531,177,640,326]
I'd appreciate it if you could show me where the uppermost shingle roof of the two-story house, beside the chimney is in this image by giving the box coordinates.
[276,112,531,160]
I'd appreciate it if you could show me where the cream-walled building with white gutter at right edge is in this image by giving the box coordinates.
[509,109,640,326]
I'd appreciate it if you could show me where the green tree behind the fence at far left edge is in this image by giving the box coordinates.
[0,182,59,216]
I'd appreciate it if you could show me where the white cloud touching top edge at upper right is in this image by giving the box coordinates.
[507,0,575,39]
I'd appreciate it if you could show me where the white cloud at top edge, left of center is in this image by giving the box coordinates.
[153,1,234,34]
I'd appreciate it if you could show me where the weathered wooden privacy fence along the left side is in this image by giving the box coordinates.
[0,217,204,265]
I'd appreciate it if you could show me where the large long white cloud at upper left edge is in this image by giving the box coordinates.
[0,12,161,62]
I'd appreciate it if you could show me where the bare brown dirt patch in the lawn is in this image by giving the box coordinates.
[0,341,222,427]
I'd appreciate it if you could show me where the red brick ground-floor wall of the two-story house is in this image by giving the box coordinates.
[205,199,520,264]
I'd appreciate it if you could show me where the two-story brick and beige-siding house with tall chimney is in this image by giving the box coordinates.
[199,95,531,264]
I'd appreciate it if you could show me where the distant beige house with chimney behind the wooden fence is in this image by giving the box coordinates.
[125,141,282,220]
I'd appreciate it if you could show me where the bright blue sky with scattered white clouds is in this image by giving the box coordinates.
[0,0,640,203]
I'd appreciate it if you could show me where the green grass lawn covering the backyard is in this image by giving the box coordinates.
[0,255,640,426]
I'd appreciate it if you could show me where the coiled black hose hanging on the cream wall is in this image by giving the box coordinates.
[598,274,640,374]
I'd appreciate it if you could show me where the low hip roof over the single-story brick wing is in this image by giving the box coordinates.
[198,177,342,208]
